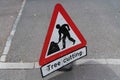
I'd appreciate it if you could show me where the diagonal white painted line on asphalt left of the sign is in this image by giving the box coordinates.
[0,0,26,62]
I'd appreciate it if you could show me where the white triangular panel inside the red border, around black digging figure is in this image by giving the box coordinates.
[46,12,81,58]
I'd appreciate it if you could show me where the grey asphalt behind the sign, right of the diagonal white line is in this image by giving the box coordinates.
[7,0,120,62]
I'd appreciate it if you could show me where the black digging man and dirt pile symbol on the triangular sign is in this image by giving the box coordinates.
[48,24,75,55]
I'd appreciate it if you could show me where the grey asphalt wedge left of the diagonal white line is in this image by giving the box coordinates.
[0,0,22,56]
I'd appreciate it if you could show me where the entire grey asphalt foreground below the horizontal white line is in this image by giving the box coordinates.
[0,62,120,80]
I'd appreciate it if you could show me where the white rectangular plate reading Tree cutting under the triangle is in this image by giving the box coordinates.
[41,47,87,77]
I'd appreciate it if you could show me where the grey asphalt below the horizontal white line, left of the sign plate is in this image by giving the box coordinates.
[0,69,42,80]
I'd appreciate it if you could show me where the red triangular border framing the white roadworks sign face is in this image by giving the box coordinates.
[39,3,87,66]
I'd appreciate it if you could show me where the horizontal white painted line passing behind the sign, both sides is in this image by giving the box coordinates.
[0,59,120,69]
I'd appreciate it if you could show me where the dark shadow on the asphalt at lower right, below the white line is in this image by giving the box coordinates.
[49,61,120,80]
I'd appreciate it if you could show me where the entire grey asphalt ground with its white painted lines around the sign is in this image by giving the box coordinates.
[0,0,120,80]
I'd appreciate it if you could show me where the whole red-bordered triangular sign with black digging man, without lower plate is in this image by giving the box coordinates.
[39,4,86,76]
